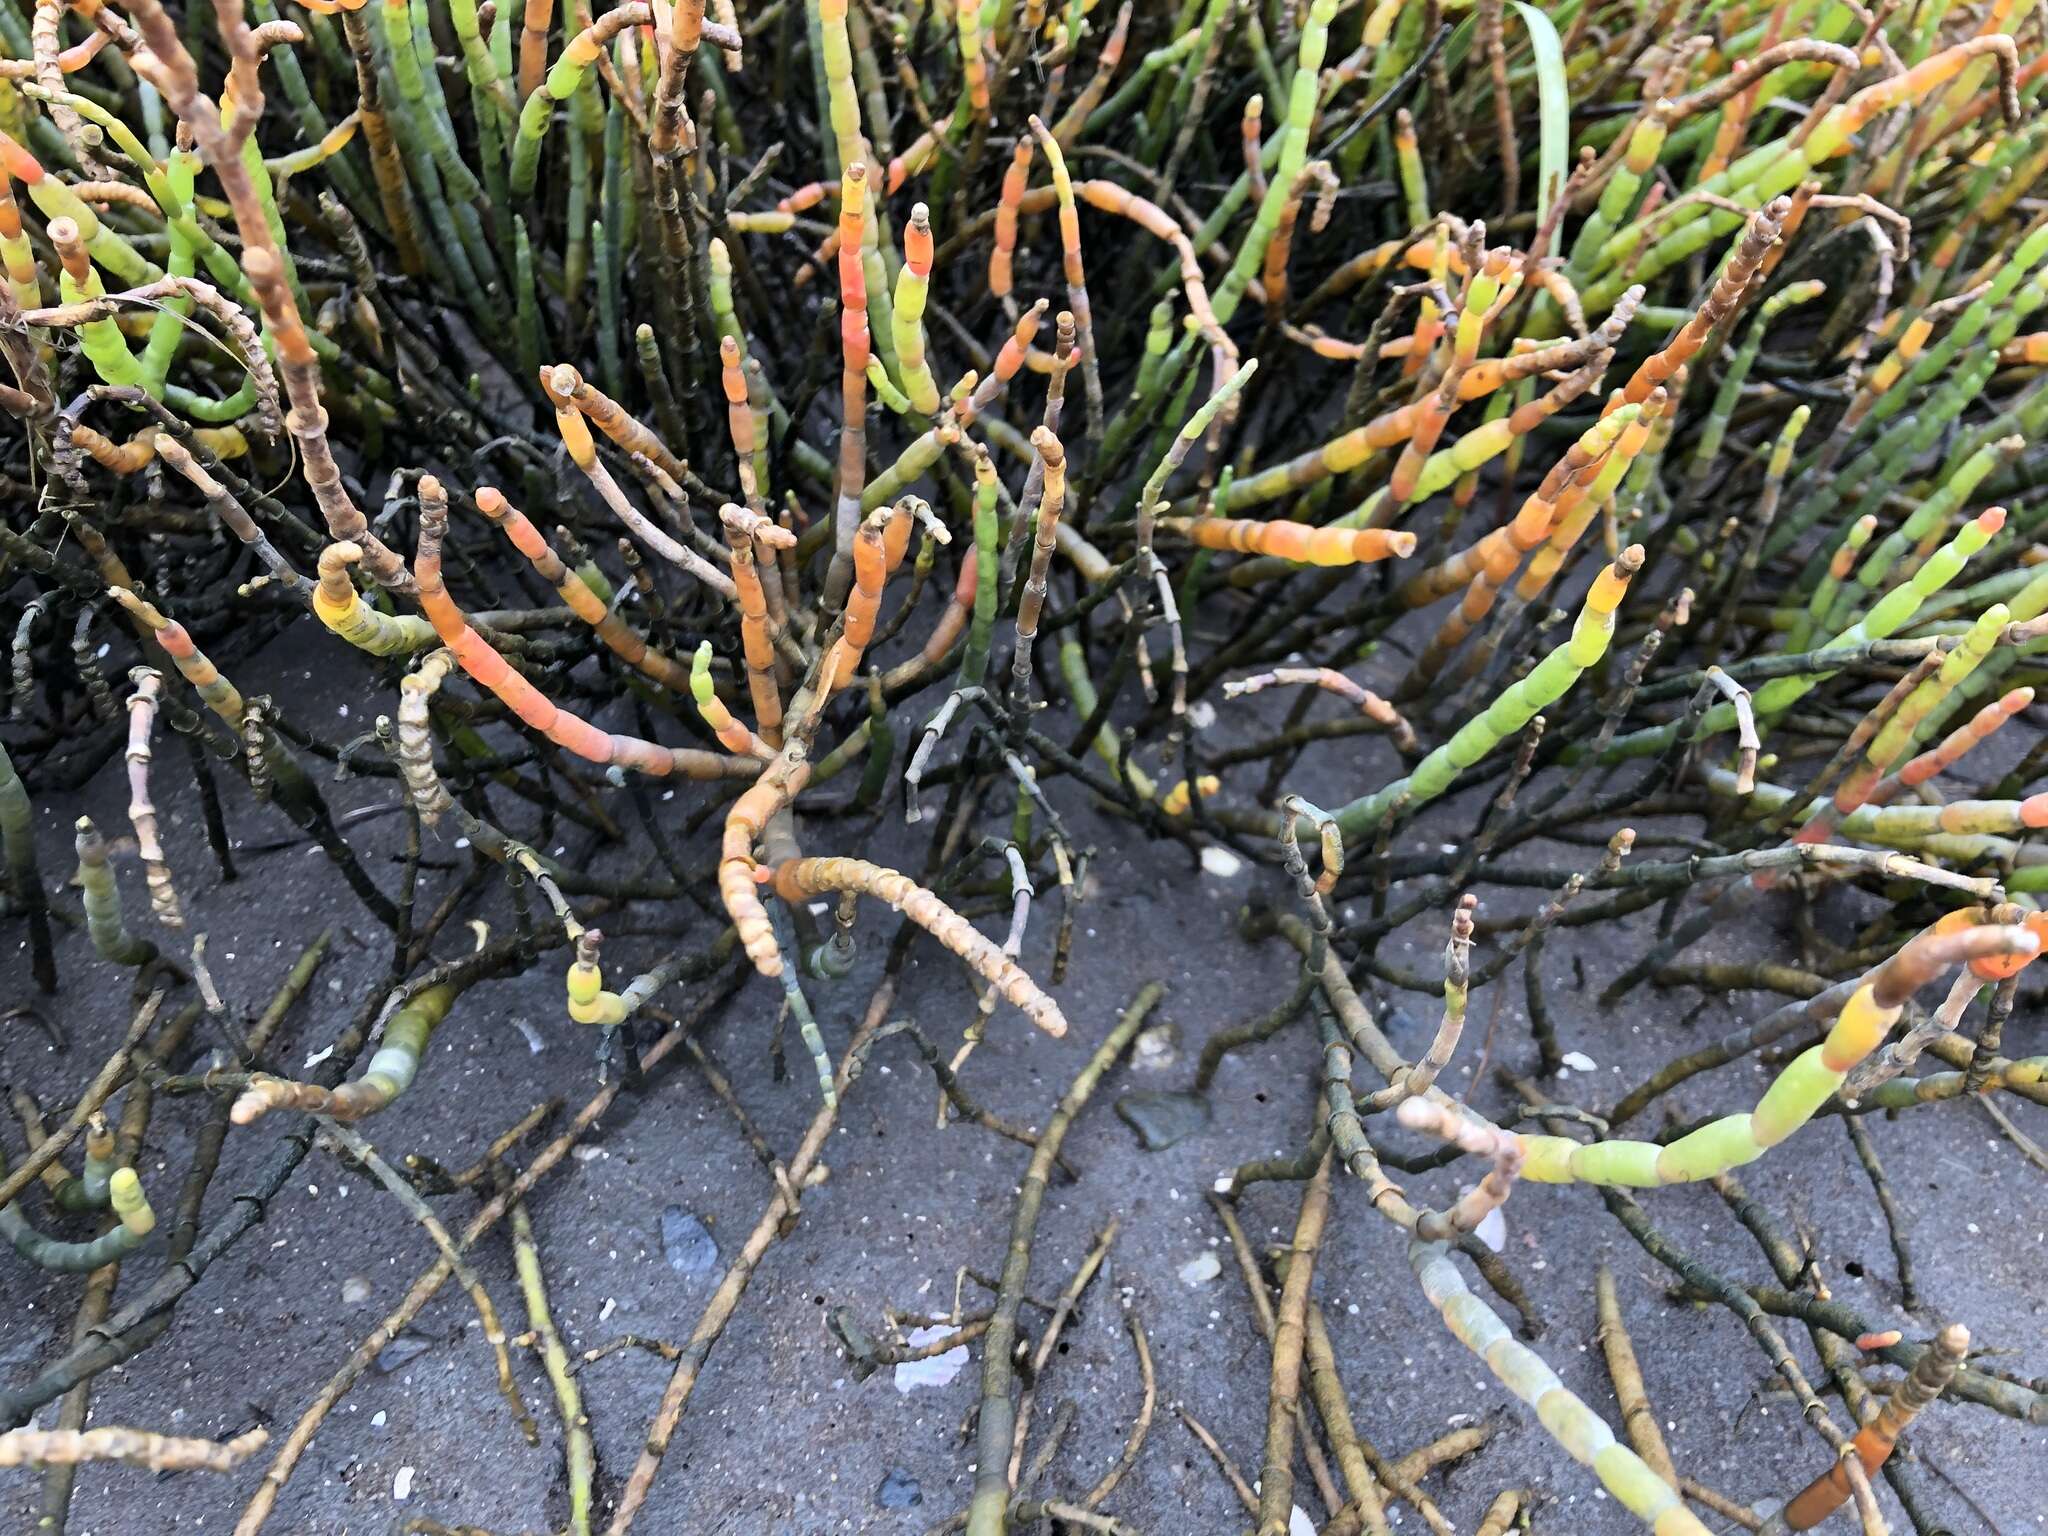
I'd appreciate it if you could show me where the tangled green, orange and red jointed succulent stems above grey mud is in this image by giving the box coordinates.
[0,0,2048,1536]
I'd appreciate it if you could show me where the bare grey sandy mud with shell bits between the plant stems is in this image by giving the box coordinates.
[0,626,2048,1536]
